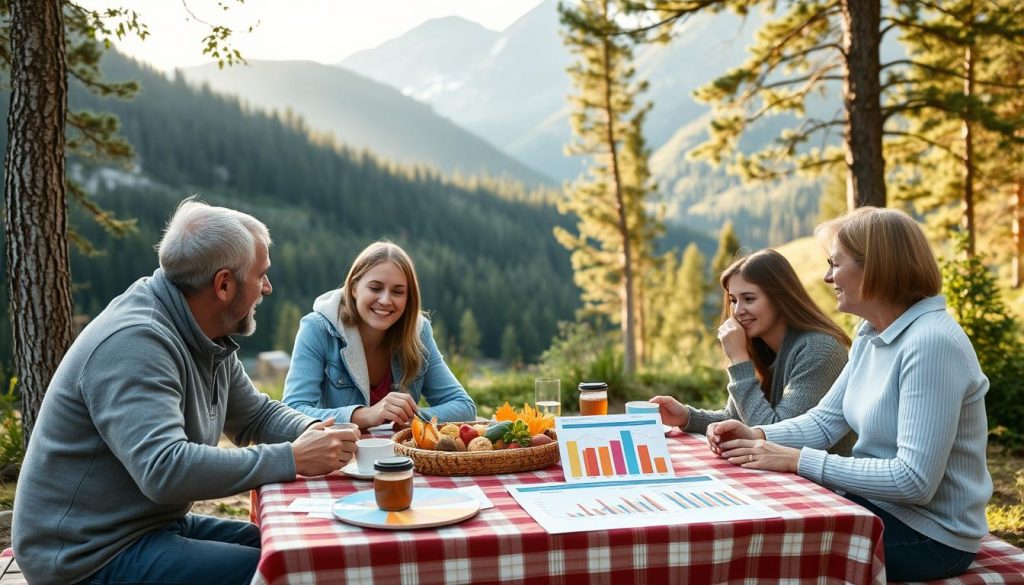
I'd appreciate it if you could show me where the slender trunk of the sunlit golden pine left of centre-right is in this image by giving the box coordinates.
[601,0,636,376]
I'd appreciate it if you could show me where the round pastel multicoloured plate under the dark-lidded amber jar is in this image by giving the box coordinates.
[331,488,480,530]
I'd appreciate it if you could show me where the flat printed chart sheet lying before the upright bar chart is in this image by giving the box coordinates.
[508,475,778,534]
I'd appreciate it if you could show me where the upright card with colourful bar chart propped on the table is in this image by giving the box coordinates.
[555,413,676,484]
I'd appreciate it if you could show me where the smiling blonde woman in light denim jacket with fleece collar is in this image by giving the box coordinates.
[284,242,476,428]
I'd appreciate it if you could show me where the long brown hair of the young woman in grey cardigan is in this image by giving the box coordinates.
[720,250,850,402]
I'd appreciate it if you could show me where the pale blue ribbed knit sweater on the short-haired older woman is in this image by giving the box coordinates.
[762,296,992,552]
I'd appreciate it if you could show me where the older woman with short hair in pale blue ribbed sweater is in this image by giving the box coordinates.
[708,207,992,581]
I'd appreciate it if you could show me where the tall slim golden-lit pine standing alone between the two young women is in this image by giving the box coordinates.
[555,0,659,375]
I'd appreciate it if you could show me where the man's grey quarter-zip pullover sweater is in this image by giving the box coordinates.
[12,269,313,583]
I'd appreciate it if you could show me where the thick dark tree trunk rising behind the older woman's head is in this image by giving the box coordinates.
[841,0,886,209]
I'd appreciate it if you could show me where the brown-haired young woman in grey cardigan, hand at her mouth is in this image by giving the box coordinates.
[651,250,853,453]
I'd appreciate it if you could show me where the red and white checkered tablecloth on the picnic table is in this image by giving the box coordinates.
[253,432,885,585]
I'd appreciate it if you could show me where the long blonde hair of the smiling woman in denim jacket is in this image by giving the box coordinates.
[338,241,427,388]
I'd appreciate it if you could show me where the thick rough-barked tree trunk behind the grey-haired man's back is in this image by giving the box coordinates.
[4,0,74,446]
